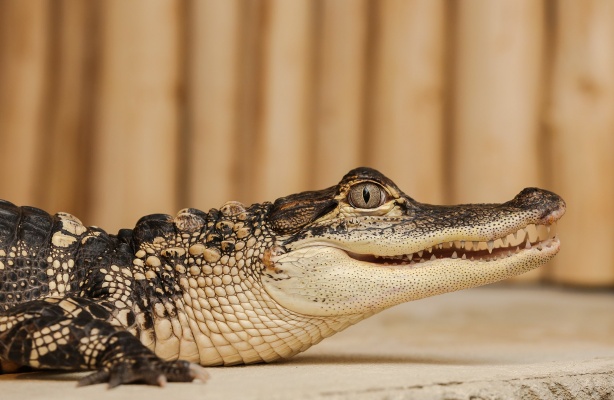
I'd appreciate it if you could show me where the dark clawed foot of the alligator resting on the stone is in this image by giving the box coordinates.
[78,357,209,388]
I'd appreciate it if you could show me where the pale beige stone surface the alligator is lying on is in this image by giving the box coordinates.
[0,286,614,400]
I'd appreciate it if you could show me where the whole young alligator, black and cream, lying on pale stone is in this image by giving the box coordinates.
[0,167,565,387]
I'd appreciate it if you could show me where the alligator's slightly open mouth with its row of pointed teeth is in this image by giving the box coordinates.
[346,222,559,267]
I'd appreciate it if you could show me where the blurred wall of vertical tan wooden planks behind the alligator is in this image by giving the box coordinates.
[0,0,614,286]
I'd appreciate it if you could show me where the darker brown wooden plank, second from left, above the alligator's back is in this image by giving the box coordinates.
[37,0,97,216]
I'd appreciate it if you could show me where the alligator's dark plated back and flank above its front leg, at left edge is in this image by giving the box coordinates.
[0,201,128,310]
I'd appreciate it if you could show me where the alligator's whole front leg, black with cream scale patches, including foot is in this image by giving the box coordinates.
[0,298,207,387]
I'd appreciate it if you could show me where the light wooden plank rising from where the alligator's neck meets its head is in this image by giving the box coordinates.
[250,0,313,201]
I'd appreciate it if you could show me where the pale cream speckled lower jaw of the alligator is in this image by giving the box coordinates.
[263,238,559,317]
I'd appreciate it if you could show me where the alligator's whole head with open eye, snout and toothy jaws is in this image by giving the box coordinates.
[262,168,565,317]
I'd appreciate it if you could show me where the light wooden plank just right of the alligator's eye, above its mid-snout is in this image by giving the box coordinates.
[366,0,445,203]
